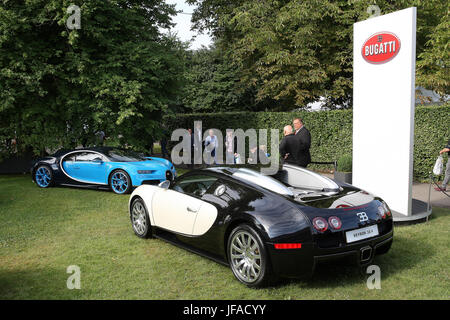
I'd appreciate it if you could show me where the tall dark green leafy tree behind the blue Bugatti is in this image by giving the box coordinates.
[0,0,183,152]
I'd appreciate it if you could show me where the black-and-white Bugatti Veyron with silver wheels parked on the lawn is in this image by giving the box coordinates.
[129,165,393,287]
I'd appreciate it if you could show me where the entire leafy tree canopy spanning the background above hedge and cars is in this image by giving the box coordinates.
[0,0,450,153]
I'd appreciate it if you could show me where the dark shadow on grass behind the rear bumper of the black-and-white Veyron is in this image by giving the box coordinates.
[276,234,435,288]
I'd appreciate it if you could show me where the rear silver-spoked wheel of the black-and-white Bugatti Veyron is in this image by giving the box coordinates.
[227,224,271,287]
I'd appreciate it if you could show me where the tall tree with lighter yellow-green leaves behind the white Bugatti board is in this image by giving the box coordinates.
[188,0,450,110]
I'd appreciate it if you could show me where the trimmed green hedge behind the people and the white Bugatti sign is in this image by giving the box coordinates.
[165,104,450,181]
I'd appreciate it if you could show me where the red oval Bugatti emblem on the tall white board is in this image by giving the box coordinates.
[361,32,400,64]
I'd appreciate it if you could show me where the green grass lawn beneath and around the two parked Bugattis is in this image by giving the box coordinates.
[0,176,450,299]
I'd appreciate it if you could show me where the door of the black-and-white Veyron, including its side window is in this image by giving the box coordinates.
[152,175,217,236]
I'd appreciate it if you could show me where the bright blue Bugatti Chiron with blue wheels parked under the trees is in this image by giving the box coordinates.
[31,147,176,194]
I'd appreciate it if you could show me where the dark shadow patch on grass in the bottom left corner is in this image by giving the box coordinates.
[0,269,86,300]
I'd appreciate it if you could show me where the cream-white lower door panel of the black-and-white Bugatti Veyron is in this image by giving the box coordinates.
[152,189,203,235]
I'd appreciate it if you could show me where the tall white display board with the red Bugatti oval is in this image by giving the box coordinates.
[353,8,416,216]
